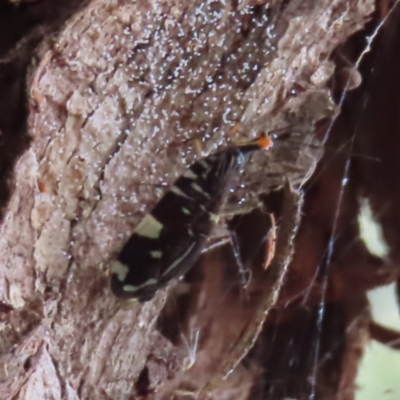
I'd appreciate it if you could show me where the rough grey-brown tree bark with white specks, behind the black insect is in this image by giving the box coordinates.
[0,0,388,399]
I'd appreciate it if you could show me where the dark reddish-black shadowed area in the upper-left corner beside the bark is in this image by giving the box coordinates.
[0,0,87,216]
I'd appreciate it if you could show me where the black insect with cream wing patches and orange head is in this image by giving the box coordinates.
[110,133,272,302]
